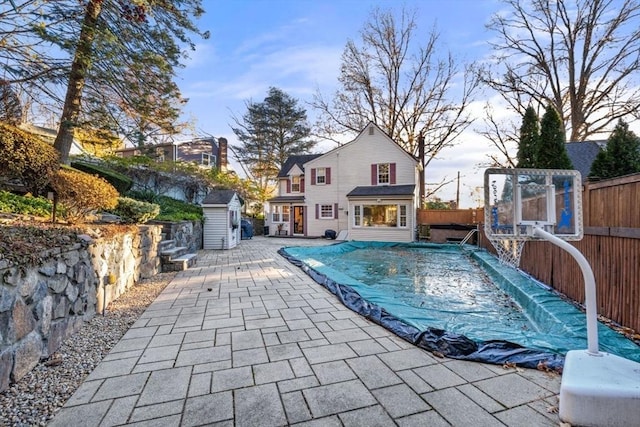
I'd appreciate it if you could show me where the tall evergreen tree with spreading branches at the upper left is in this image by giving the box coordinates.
[0,0,208,163]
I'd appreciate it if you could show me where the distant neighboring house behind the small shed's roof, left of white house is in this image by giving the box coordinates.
[115,138,228,171]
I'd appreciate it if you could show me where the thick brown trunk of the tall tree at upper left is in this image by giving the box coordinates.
[54,0,102,164]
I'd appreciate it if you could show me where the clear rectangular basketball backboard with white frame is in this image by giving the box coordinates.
[484,168,582,240]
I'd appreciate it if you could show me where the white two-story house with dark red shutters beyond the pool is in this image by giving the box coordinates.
[267,123,419,242]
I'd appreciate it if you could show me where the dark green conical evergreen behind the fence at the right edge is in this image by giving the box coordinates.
[589,120,640,178]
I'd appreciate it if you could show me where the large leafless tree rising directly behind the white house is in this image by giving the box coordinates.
[312,9,478,171]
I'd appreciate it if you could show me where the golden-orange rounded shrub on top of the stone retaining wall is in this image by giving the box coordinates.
[51,168,118,223]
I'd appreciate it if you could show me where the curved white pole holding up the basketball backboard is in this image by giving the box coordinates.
[533,225,601,356]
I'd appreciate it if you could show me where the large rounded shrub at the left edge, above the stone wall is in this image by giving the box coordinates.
[0,123,60,195]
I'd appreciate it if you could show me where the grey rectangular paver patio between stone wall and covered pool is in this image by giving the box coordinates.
[49,237,560,427]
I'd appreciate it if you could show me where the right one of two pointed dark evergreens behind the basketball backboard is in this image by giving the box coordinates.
[535,104,573,169]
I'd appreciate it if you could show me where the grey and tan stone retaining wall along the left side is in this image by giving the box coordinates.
[0,225,162,391]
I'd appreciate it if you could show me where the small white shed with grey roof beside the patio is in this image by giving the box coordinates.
[202,190,242,249]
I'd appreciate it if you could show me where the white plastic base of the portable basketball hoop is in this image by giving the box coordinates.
[559,350,640,427]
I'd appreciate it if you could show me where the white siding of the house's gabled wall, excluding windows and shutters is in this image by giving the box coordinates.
[305,125,418,241]
